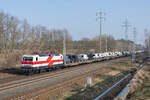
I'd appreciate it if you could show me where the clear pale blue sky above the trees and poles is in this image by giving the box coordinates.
[0,0,150,43]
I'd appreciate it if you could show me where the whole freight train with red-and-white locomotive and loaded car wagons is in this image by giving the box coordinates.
[21,51,142,73]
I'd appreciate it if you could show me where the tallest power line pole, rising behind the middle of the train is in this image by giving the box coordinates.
[96,11,105,52]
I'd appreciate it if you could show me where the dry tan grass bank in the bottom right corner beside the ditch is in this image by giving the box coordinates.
[127,65,150,100]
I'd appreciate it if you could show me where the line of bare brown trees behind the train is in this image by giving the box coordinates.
[0,12,140,53]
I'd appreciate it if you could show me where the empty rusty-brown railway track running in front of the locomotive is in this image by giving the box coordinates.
[0,62,101,93]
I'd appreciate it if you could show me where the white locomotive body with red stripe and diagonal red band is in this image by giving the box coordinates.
[22,54,63,70]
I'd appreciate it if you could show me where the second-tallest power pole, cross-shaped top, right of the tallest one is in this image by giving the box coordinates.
[122,19,131,50]
